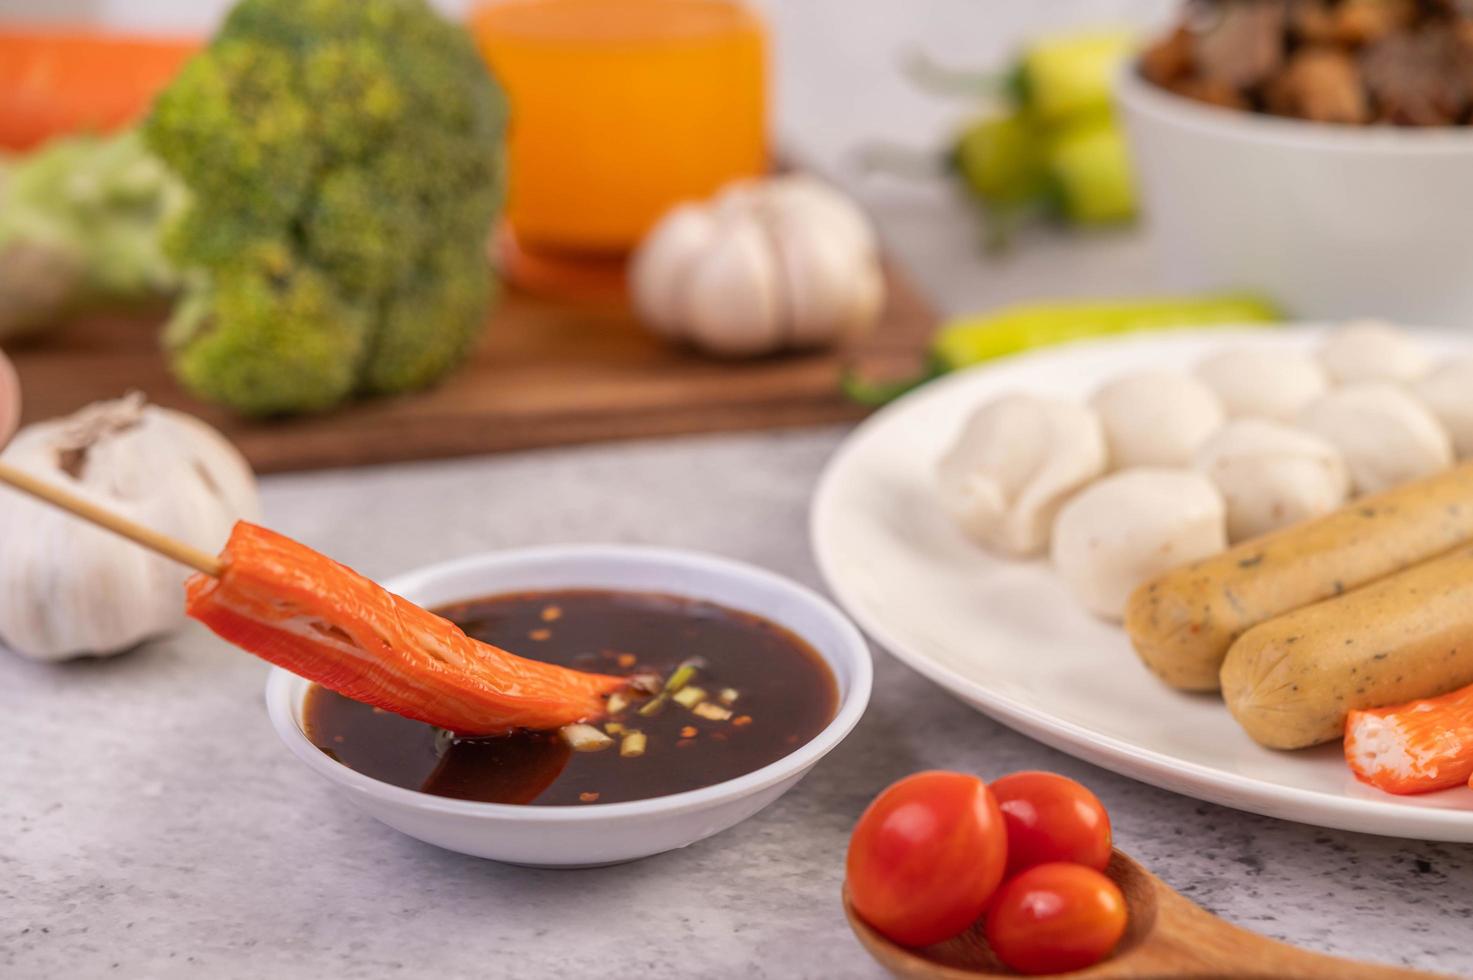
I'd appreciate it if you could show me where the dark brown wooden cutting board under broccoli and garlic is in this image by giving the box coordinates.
[9,259,937,473]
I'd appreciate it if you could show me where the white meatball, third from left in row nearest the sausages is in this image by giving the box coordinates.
[1299,382,1452,494]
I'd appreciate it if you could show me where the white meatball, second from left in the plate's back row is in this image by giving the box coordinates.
[1090,370,1223,470]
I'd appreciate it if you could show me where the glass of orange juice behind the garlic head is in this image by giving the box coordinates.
[471,0,767,291]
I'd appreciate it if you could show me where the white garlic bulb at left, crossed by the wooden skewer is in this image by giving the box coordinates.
[0,395,261,660]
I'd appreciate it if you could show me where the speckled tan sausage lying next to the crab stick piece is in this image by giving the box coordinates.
[1223,548,1473,749]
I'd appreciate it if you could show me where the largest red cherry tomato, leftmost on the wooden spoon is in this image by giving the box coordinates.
[847,772,1008,946]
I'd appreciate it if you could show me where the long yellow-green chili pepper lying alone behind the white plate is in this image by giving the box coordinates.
[843,293,1283,405]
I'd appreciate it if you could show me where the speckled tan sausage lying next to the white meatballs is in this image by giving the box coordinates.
[1125,463,1473,691]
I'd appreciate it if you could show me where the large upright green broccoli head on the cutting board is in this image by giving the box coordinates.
[143,0,507,416]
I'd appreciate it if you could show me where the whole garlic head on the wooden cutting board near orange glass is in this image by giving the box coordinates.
[629,177,885,357]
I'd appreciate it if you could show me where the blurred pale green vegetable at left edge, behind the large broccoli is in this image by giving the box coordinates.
[0,131,183,339]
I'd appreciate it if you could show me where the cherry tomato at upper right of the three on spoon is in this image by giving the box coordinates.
[991,772,1111,877]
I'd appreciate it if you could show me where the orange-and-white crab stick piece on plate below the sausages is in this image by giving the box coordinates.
[1345,684,1473,793]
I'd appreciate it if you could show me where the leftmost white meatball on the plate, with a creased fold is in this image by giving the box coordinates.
[937,395,1105,557]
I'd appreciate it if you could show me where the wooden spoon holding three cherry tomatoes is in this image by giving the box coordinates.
[844,850,1435,980]
